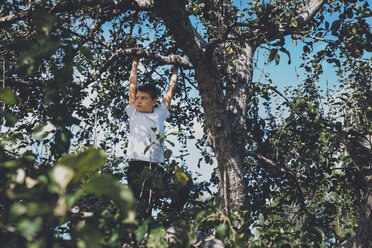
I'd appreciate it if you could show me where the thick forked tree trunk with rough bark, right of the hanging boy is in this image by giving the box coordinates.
[156,0,253,213]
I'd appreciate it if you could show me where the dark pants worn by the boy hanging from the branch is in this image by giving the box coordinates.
[127,161,161,220]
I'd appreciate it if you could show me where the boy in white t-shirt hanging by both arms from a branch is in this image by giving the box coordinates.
[125,55,178,218]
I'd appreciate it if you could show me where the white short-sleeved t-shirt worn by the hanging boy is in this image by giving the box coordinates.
[125,103,169,163]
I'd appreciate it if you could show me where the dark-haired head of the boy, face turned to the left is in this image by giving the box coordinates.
[135,84,159,113]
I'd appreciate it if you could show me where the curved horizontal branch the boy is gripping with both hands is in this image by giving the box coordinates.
[80,48,193,88]
